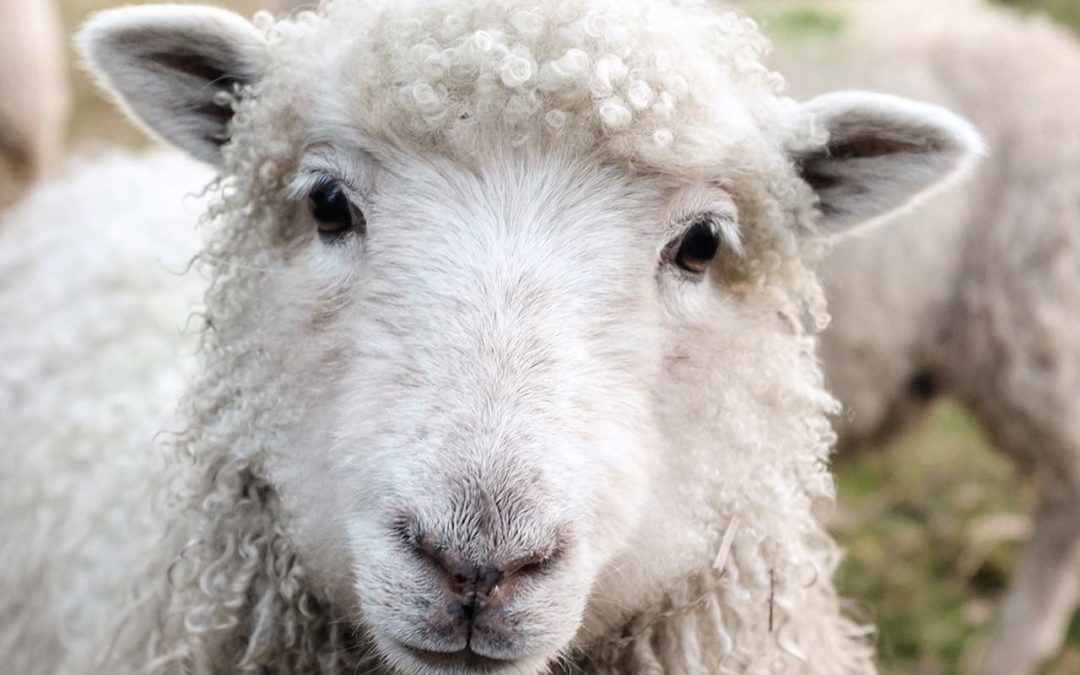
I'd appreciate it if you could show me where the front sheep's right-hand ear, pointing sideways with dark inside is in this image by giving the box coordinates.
[795,92,983,234]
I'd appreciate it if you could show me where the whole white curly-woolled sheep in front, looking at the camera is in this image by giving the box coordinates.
[0,0,982,675]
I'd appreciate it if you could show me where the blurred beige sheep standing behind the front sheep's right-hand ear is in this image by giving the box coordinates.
[747,0,1080,675]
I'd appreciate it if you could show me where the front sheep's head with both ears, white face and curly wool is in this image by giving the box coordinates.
[82,0,978,674]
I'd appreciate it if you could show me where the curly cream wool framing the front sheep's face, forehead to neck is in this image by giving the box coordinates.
[0,0,873,674]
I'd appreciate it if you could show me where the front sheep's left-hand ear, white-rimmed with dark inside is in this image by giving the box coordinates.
[79,5,267,165]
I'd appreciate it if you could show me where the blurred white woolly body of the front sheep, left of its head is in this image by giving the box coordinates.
[0,153,211,673]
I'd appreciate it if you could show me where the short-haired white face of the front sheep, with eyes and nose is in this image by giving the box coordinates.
[267,148,738,672]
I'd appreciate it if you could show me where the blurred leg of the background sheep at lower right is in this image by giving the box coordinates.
[981,480,1080,675]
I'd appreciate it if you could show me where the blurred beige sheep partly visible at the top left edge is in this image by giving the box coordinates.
[0,0,70,205]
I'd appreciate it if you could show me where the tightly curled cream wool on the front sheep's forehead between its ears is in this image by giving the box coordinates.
[263,0,792,173]
